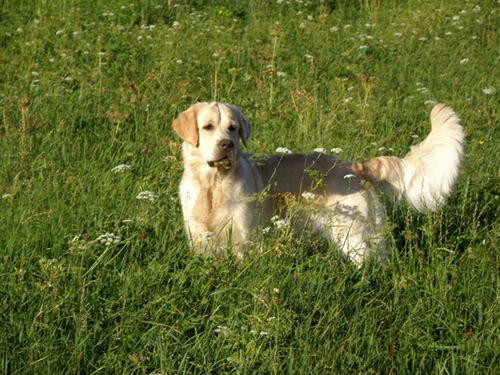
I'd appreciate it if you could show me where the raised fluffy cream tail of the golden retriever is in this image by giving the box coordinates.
[351,104,465,211]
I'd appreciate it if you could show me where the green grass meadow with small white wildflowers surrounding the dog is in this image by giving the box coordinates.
[0,0,500,375]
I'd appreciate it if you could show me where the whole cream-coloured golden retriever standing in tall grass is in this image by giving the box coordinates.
[172,102,465,266]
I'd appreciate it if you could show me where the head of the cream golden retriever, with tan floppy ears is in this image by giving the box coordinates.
[172,102,252,169]
